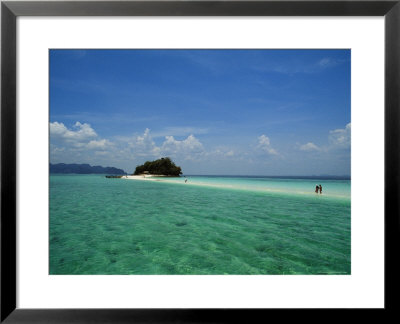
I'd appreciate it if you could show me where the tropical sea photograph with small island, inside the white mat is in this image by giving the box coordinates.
[46,48,351,276]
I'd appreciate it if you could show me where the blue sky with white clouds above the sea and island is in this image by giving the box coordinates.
[50,50,351,175]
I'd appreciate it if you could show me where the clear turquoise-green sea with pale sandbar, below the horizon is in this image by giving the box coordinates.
[49,175,351,275]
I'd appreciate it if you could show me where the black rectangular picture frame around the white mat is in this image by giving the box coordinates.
[0,0,400,323]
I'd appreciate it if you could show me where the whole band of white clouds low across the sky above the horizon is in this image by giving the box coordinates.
[50,122,351,173]
